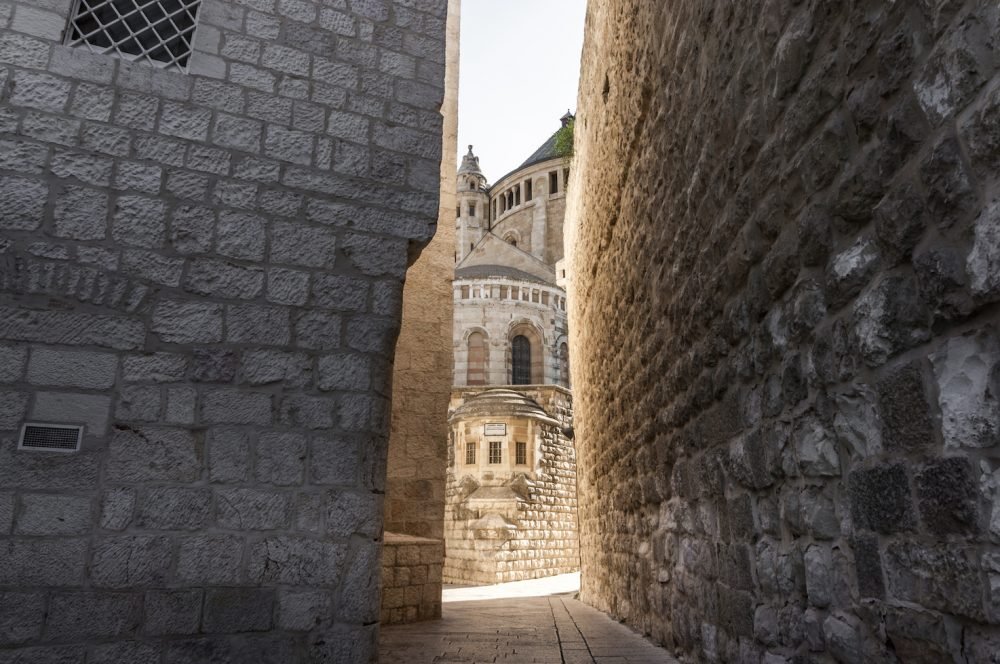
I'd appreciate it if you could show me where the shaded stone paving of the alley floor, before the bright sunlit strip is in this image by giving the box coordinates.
[379,596,677,664]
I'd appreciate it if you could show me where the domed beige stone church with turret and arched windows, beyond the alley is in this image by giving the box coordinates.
[444,136,579,584]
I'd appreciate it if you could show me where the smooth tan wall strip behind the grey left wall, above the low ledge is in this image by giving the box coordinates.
[385,0,461,538]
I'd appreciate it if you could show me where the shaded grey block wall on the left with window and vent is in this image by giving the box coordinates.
[0,0,447,663]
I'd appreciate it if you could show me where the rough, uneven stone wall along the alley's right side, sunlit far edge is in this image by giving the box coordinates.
[567,0,1000,663]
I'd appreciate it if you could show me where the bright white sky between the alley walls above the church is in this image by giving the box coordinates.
[458,0,587,183]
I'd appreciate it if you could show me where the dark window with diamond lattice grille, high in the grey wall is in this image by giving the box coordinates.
[67,0,202,70]
